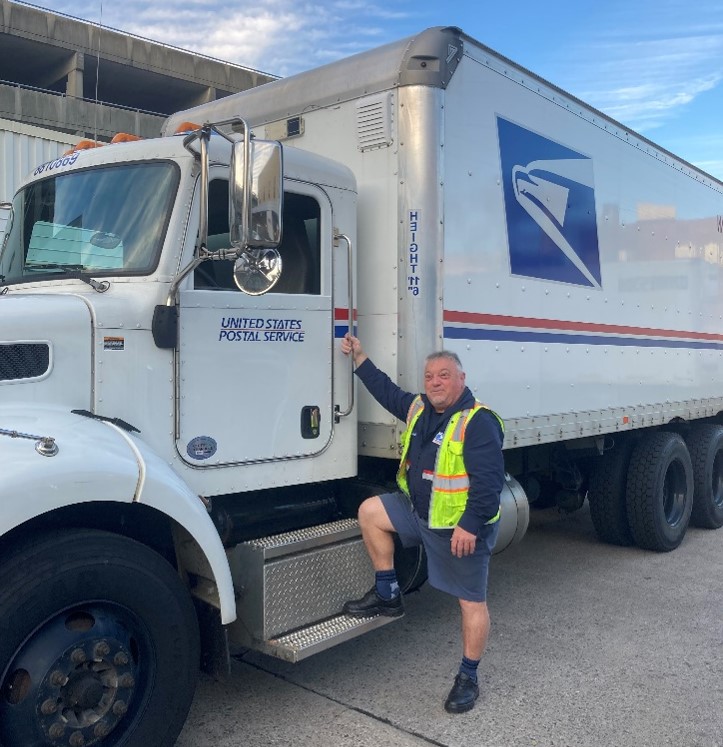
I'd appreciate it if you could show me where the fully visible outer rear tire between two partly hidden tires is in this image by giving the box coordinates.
[626,431,693,552]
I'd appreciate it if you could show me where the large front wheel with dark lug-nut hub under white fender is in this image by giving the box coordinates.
[0,529,199,747]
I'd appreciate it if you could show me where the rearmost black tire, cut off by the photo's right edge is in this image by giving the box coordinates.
[686,425,723,529]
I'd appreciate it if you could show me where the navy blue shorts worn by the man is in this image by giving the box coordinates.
[379,493,499,602]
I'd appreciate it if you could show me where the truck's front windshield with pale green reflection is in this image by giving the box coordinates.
[0,162,178,285]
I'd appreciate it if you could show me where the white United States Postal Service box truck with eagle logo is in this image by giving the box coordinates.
[0,27,723,747]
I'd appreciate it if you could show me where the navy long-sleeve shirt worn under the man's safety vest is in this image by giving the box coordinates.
[356,358,504,535]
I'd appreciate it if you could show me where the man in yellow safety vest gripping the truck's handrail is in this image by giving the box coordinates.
[341,333,504,713]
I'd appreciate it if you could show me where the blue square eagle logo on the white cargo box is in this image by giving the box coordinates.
[497,117,602,288]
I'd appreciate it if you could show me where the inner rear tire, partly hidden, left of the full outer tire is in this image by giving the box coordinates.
[587,441,634,547]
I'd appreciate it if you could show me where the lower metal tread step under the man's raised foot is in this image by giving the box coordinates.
[259,615,400,662]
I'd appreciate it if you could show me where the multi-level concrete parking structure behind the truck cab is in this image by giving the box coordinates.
[0,0,274,142]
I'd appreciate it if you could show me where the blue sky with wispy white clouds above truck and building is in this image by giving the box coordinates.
[28,0,723,179]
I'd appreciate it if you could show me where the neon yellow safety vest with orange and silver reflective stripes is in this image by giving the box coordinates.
[397,395,505,529]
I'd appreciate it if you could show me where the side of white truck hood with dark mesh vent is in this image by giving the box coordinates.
[0,293,93,410]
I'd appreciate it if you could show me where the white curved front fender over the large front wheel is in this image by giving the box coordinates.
[0,405,236,624]
